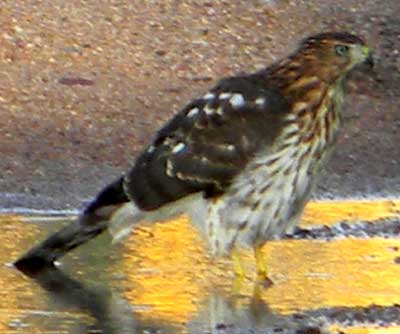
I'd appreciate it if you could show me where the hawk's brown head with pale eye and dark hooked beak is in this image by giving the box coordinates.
[295,32,373,80]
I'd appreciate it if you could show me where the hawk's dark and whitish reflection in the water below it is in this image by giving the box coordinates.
[19,267,329,334]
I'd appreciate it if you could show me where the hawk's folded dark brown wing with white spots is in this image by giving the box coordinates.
[124,75,289,210]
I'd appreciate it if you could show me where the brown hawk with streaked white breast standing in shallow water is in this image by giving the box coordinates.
[16,33,372,277]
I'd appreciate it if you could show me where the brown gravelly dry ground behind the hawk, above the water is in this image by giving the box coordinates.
[0,0,400,209]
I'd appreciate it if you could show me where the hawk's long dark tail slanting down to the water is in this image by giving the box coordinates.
[14,177,129,272]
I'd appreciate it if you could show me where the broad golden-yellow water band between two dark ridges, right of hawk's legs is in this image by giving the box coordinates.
[263,238,400,314]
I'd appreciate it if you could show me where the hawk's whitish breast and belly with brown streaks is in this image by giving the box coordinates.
[206,83,342,255]
